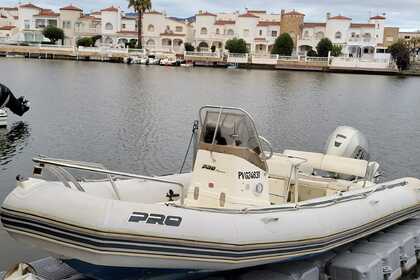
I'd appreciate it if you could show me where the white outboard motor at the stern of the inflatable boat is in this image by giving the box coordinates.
[325,126,369,160]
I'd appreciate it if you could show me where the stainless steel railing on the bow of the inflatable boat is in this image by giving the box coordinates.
[32,157,185,205]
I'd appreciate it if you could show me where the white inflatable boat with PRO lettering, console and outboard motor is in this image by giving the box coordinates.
[1,106,420,271]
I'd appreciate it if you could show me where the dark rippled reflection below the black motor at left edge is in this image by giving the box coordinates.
[0,122,31,171]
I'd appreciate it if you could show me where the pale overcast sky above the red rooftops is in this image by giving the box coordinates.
[0,0,420,30]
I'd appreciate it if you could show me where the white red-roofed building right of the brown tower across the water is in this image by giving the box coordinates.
[297,15,385,57]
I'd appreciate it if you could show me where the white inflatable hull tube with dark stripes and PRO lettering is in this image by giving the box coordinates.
[1,178,420,270]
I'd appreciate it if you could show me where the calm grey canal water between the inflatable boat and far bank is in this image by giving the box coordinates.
[0,58,420,270]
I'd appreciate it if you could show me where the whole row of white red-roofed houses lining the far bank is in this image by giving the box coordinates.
[0,4,392,57]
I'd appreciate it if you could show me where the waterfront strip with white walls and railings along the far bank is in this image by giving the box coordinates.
[0,44,399,75]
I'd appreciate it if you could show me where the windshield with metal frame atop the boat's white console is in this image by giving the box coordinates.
[200,108,266,170]
